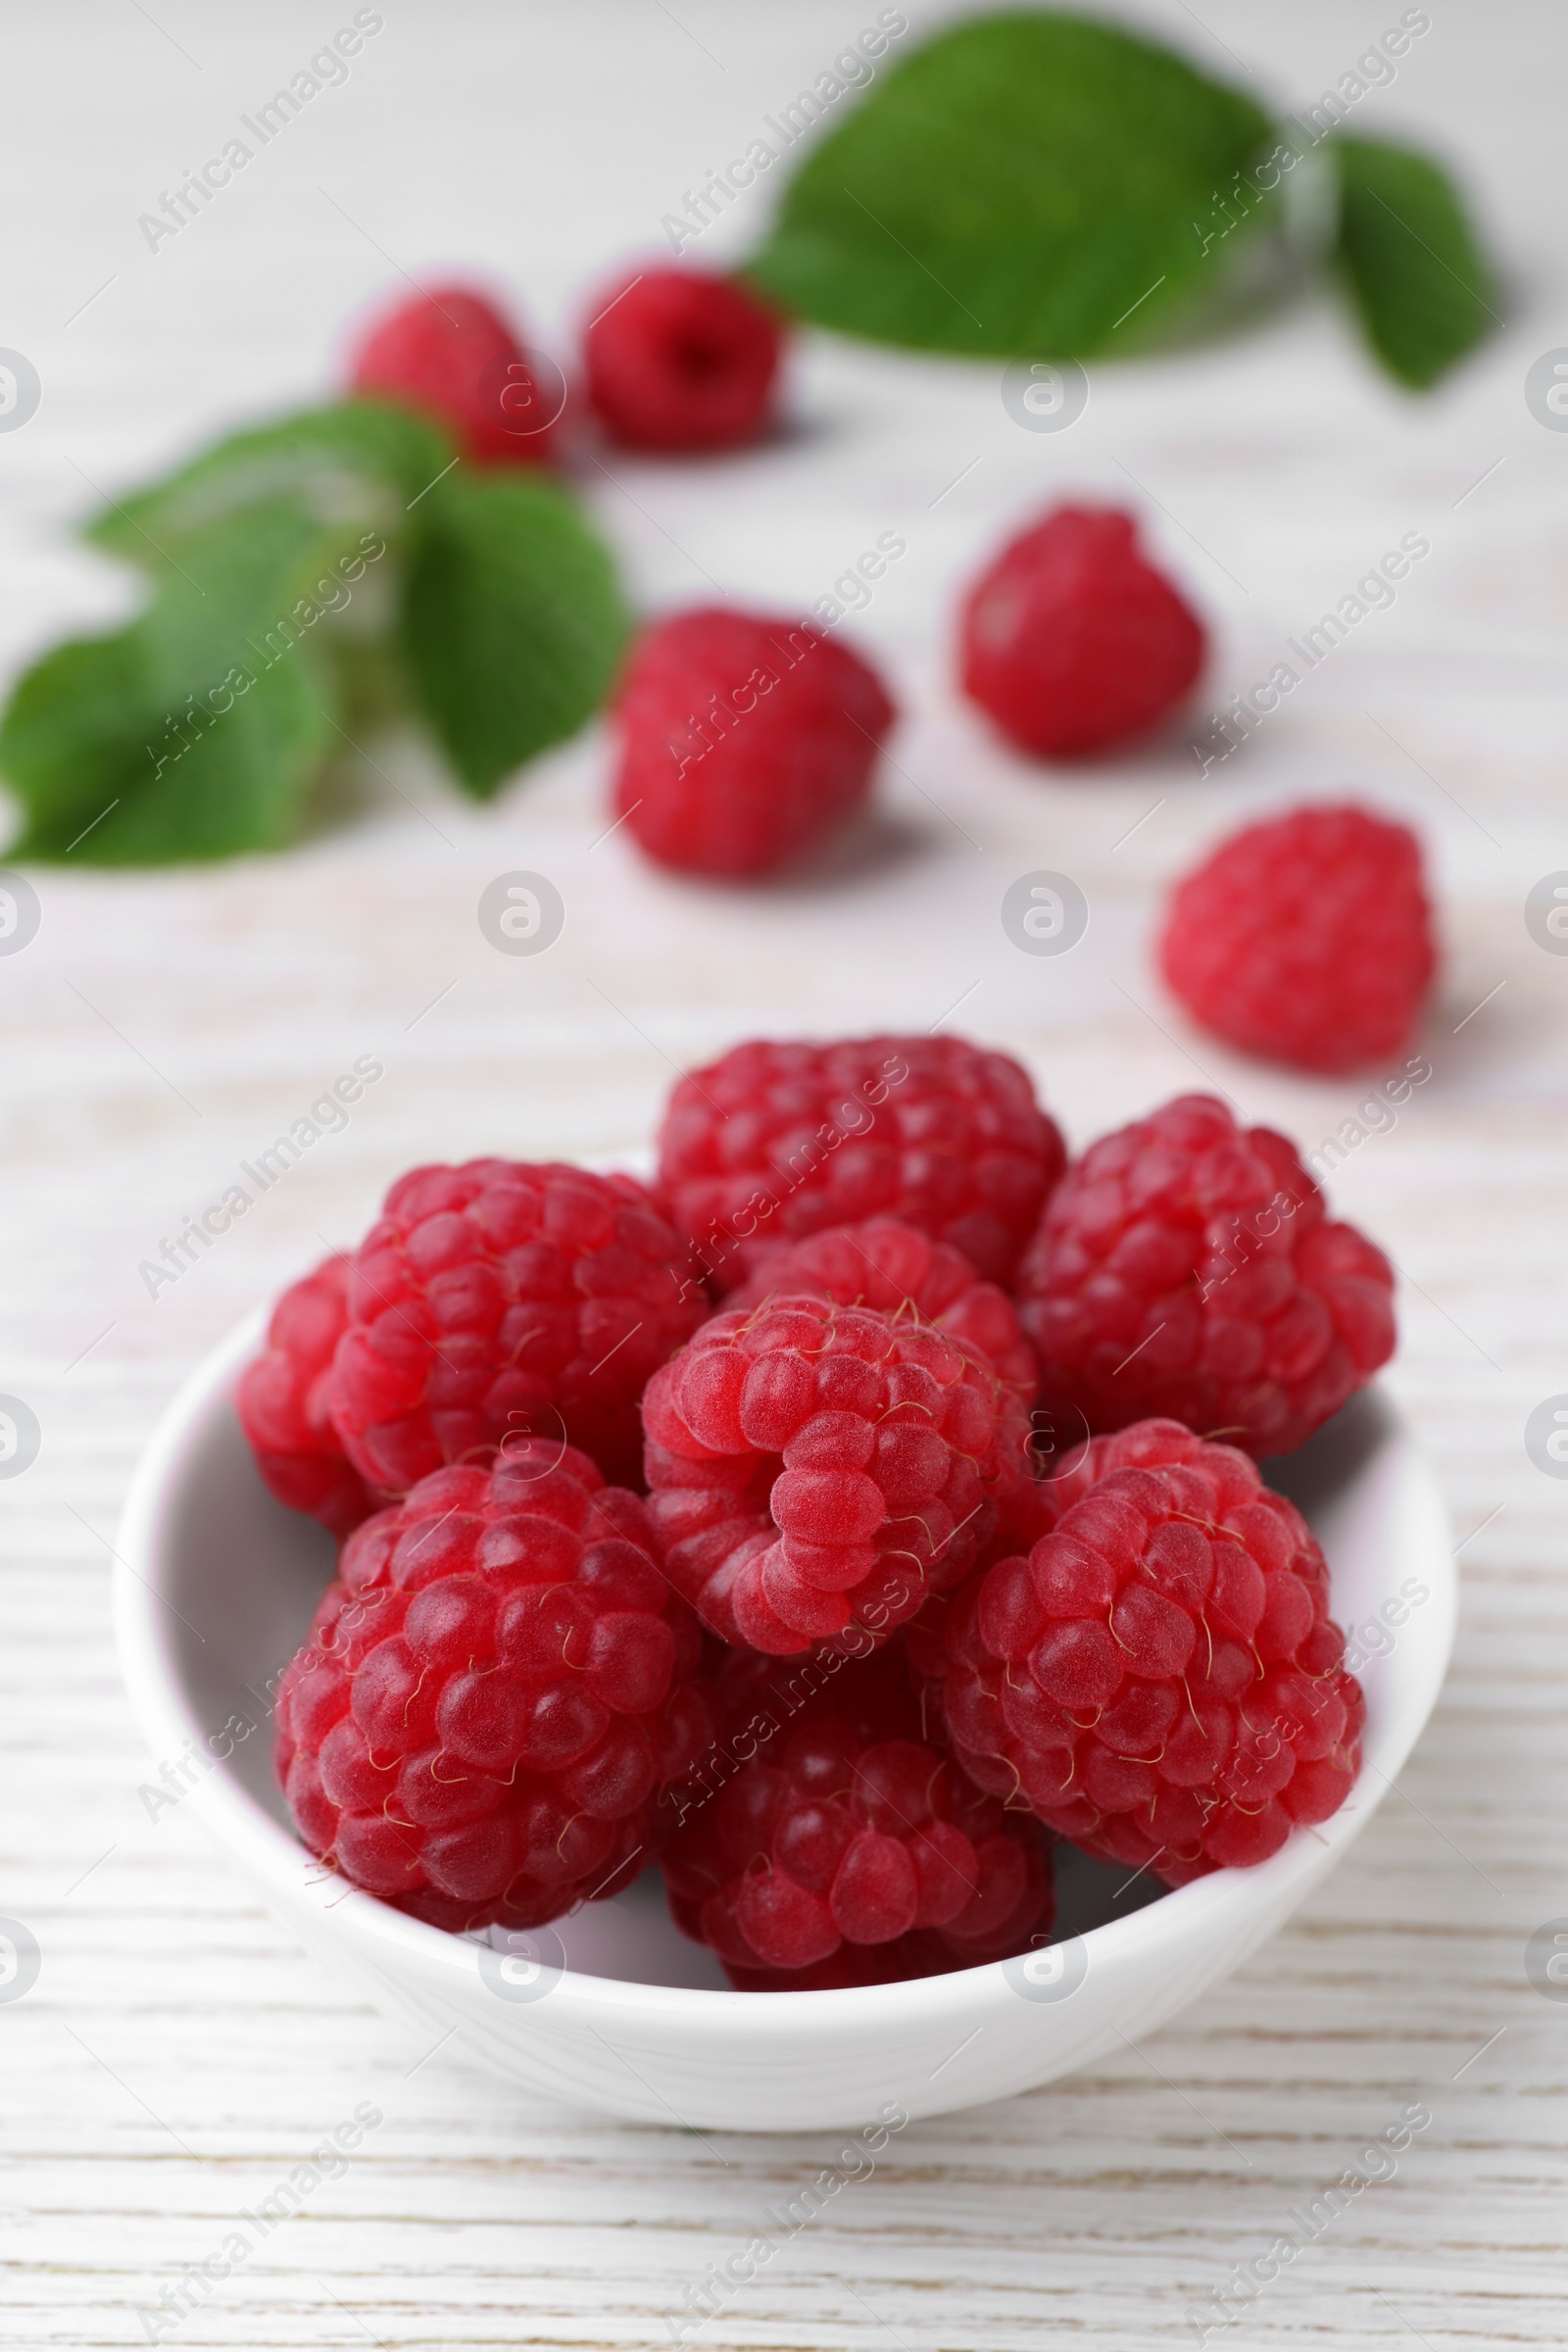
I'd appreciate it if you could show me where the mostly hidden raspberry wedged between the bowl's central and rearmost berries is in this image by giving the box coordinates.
[726,1216,1039,1404]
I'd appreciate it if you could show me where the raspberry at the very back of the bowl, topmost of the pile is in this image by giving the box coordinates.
[659,1037,1067,1287]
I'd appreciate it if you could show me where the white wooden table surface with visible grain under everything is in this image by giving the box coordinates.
[0,0,1568,2352]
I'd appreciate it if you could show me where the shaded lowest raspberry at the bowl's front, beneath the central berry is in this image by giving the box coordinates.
[662,1653,1054,1992]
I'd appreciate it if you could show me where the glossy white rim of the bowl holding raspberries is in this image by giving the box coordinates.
[113,1305,1457,2041]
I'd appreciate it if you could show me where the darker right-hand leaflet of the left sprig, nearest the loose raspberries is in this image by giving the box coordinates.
[402,470,627,800]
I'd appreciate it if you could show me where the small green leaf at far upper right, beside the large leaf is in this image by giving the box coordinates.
[1331,139,1502,390]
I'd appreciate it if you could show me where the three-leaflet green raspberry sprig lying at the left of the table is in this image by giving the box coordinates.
[0,400,627,863]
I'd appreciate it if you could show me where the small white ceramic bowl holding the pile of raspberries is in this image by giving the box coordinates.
[116,1315,1457,2131]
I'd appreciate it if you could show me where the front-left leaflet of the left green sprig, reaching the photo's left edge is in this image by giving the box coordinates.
[0,499,355,865]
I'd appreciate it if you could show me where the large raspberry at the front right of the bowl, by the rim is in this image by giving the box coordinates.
[921,1425,1366,1886]
